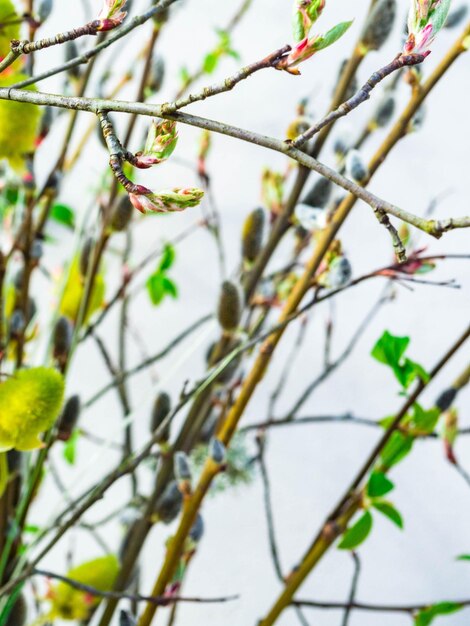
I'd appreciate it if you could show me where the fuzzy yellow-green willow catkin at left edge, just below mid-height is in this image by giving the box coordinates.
[0,367,65,451]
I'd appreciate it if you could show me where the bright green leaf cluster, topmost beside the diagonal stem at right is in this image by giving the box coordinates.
[371,330,429,389]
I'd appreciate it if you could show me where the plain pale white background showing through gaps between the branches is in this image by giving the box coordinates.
[23,0,470,626]
